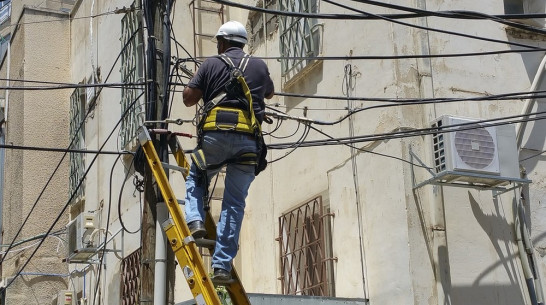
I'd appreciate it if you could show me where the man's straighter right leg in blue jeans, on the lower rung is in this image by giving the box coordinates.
[212,164,254,272]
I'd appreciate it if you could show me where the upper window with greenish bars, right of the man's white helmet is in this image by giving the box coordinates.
[279,0,321,79]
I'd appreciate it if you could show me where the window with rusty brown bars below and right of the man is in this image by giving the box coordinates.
[278,196,335,296]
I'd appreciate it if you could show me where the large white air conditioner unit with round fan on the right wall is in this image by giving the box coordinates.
[432,115,520,186]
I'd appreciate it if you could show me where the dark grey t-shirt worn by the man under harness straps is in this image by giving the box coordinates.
[188,48,274,123]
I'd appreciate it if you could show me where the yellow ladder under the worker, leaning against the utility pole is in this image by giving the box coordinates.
[138,127,250,305]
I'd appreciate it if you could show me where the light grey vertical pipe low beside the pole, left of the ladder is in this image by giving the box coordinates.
[154,202,169,305]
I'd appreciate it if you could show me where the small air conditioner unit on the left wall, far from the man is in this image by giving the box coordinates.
[66,213,96,263]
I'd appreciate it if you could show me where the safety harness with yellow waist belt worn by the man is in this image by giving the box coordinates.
[191,54,263,172]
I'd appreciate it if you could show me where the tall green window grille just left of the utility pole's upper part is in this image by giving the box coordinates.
[120,4,145,149]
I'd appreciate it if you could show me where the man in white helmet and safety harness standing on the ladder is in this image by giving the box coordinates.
[183,21,274,281]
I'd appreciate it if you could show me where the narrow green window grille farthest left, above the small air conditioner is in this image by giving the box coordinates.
[69,88,85,199]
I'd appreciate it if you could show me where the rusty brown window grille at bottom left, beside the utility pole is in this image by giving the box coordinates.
[120,248,142,305]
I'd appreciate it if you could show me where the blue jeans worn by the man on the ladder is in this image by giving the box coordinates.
[185,131,257,271]
